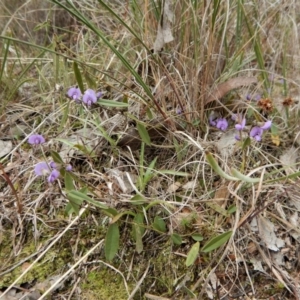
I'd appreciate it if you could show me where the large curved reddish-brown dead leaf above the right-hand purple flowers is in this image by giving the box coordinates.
[205,77,257,104]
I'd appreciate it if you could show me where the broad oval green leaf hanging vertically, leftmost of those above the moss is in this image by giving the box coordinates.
[104,223,120,261]
